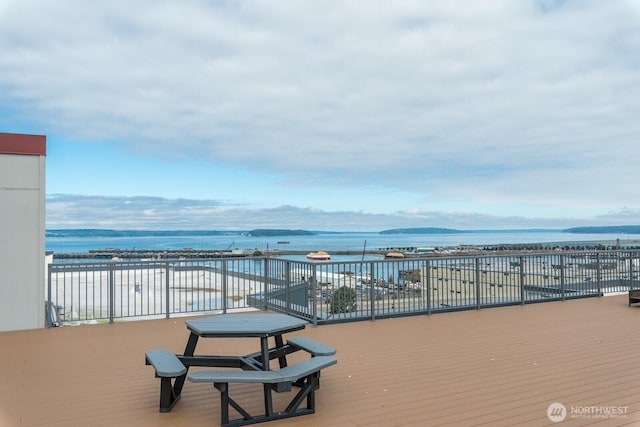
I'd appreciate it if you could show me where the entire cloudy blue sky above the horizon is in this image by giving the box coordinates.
[0,0,640,231]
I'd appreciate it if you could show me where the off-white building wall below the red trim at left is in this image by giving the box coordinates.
[0,137,46,331]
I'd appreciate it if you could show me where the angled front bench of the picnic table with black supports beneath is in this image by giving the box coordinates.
[188,356,337,427]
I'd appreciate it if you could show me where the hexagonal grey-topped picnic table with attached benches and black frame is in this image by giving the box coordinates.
[146,313,336,426]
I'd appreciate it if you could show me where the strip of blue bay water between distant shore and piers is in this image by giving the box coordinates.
[46,231,640,253]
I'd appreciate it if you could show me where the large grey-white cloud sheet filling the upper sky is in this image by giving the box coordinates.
[0,0,640,224]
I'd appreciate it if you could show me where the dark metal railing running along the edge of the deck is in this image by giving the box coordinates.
[47,251,640,325]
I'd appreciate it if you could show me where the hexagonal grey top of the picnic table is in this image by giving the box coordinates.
[186,313,308,338]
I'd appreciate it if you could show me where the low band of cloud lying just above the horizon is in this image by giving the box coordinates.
[46,195,640,231]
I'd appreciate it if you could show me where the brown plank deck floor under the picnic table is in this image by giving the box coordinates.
[0,296,640,427]
